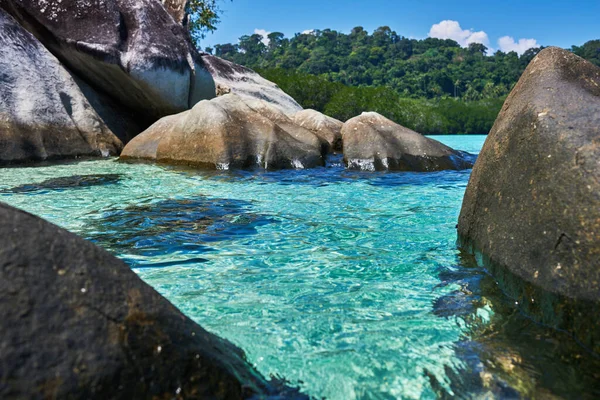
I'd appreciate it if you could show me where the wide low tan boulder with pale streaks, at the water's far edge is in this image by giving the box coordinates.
[121,94,323,169]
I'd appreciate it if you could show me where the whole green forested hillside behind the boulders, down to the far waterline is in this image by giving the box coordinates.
[206,27,600,133]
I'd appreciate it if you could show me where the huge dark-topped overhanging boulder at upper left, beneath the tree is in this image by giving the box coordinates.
[0,0,215,122]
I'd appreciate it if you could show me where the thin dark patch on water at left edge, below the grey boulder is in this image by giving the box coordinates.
[0,174,122,195]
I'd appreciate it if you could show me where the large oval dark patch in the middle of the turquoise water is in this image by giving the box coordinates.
[86,196,275,268]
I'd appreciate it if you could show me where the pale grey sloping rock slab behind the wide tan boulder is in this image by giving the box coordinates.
[202,54,302,117]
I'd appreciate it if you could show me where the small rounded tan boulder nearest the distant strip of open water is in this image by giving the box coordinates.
[342,112,473,172]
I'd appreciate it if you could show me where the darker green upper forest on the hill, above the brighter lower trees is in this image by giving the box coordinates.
[214,26,600,101]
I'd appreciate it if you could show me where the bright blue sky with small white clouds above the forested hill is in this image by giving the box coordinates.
[202,0,600,52]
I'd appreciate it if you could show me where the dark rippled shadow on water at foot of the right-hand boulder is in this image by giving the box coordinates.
[426,254,600,399]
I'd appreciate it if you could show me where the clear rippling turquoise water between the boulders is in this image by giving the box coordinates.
[0,136,491,399]
